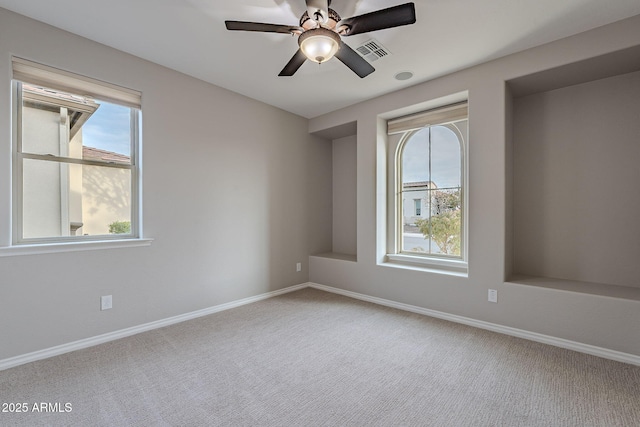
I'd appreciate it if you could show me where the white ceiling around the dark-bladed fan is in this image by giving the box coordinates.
[0,0,640,118]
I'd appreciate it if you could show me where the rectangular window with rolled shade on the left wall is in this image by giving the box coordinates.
[12,58,141,244]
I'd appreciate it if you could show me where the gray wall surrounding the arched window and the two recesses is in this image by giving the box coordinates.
[309,16,640,355]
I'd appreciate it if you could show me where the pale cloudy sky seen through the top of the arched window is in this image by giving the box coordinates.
[402,126,460,188]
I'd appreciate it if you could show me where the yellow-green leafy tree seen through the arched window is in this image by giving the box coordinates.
[416,190,462,255]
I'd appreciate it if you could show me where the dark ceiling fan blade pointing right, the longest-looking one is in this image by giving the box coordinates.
[336,3,416,36]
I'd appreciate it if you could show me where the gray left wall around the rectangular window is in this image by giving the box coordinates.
[0,9,331,360]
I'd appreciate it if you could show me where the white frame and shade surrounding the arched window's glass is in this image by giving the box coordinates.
[385,101,469,276]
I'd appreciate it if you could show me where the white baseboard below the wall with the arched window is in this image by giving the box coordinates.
[309,283,640,366]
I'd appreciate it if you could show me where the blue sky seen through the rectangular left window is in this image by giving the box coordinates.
[82,101,131,156]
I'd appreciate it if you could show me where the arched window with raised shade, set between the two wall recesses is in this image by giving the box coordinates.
[387,102,468,271]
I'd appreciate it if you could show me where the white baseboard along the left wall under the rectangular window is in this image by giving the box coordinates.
[0,283,309,371]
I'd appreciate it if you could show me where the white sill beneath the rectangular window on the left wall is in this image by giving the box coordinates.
[0,239,153,257]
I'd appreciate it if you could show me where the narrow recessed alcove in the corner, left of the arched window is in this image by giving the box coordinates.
[312,118,358,262]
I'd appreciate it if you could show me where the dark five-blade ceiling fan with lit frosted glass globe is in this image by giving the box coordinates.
[225,0,416,78]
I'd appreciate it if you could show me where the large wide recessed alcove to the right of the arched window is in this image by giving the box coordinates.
[506,46,640,300]
